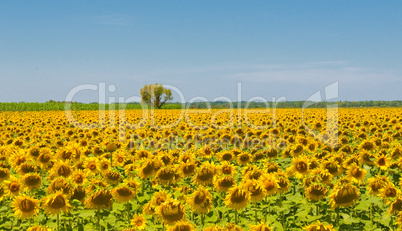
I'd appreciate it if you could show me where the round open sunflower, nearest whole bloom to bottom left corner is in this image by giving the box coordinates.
[11,196,39,219]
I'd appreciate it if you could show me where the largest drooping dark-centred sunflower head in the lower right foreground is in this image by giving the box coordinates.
[329,183,360,209]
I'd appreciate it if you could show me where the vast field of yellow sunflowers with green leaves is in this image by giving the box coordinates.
[0,108,402,231]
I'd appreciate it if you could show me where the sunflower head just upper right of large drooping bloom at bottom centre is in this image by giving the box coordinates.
[187,186,213,213]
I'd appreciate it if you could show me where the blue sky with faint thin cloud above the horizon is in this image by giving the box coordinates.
[0,0,402,102]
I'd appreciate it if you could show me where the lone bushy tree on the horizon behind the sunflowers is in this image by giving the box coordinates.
[140,83,173,108]
